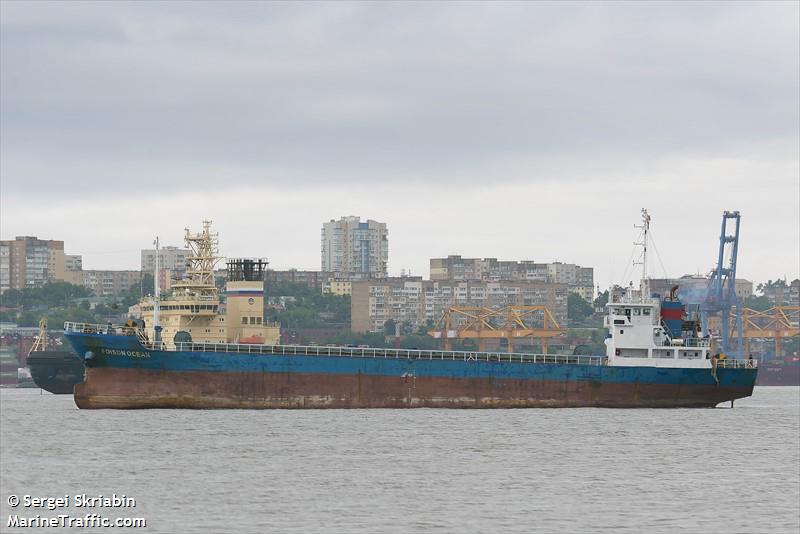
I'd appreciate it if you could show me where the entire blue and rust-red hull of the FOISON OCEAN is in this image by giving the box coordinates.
[66,332,757,408]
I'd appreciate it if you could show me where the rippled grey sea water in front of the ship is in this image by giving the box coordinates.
[0,388,800,534]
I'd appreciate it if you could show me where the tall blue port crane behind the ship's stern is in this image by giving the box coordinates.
[700,211,743,358]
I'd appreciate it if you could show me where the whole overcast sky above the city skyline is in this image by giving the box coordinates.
[0,1,800,294]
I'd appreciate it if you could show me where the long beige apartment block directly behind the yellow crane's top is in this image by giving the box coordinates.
[351,277,569,332]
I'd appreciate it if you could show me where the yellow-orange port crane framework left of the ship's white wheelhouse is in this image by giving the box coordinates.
[428,306,566,354]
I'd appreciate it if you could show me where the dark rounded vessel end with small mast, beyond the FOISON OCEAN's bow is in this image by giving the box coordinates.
[27,318,85,395]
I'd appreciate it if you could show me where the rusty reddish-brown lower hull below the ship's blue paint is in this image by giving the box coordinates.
[74,368,752,409]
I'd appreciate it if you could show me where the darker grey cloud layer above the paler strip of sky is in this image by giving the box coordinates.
[0,3,800,194]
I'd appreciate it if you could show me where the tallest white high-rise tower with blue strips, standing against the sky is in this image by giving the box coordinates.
[322,216,389,280]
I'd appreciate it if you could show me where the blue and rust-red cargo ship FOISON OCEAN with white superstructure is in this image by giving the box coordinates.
[64,217,758,409]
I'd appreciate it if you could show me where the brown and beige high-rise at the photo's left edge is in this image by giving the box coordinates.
[0,236,64,291]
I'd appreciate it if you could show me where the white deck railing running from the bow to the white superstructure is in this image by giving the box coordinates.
[64,322,606,366]
